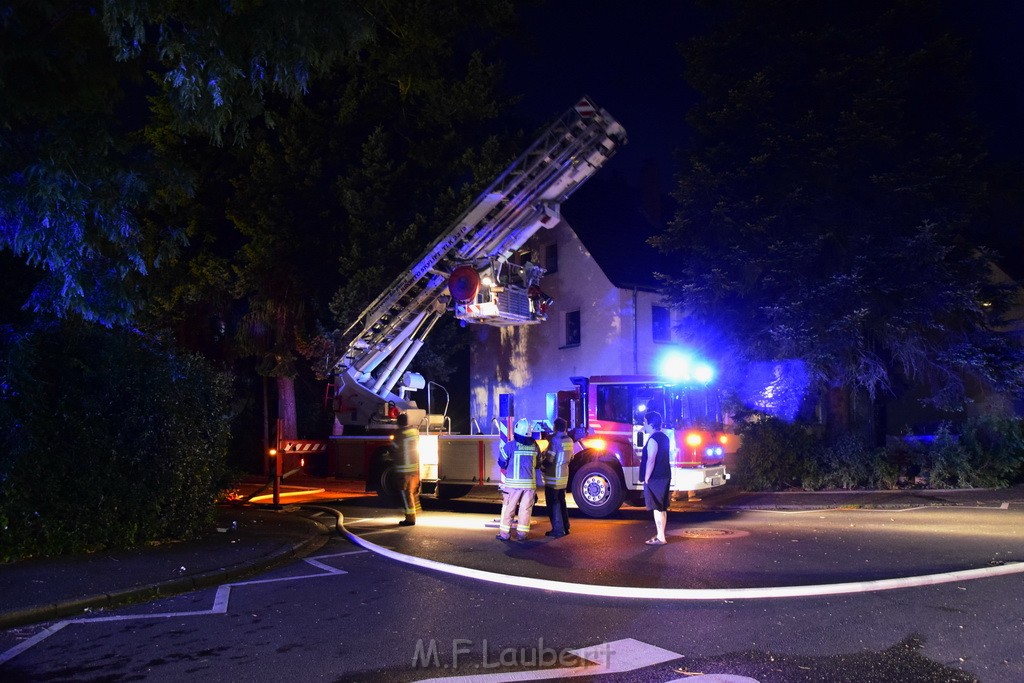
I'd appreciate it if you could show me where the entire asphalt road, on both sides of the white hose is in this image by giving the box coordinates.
[0,504,1024,683]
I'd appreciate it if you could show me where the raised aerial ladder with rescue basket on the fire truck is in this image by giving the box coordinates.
[333,96,627,428]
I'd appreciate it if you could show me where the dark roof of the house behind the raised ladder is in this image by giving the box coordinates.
[562,173,672,290]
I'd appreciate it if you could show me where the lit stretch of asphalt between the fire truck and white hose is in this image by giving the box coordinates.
[340,501,1024,589]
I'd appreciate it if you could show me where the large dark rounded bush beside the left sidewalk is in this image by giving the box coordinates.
[0,323,229,561]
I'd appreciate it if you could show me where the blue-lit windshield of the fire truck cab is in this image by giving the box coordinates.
[596,383,722,429]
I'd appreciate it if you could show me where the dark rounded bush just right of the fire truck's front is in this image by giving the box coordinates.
[736,415,820,490]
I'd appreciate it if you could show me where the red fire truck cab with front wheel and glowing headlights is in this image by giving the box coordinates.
[557,375,734,517]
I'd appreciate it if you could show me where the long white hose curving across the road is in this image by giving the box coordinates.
[339,522,1024,600]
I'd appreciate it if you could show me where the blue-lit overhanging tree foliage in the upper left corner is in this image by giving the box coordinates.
[0,0,367,325]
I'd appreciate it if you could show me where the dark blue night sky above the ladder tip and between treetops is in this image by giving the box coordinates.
[508,0,1024,184]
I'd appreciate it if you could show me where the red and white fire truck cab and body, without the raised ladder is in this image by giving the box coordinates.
[319,375,735,517]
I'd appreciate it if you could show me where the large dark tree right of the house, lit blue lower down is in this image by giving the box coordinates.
[654,0,1024,436]
